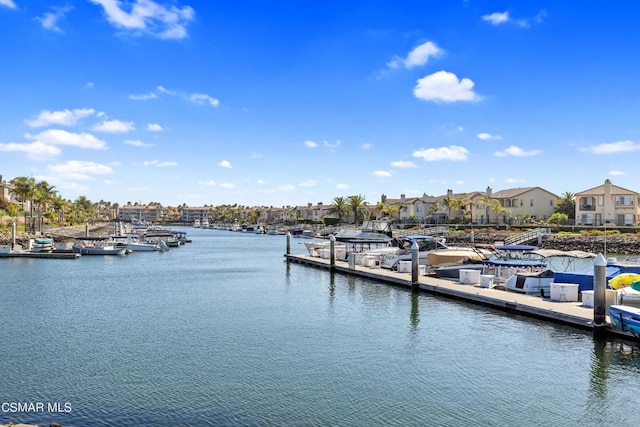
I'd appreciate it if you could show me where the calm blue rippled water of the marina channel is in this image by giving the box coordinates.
[0,228,640,427]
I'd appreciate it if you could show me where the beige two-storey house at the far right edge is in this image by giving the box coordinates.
[576,179,640,227]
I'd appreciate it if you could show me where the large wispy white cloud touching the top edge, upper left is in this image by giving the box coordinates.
[90,0,195,39]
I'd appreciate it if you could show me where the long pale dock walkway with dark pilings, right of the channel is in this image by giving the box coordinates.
[285,254,639,342]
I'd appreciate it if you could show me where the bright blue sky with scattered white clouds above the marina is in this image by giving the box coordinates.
[0,0,640,206]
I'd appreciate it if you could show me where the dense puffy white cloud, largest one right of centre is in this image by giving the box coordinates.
[413,71,482,102]
